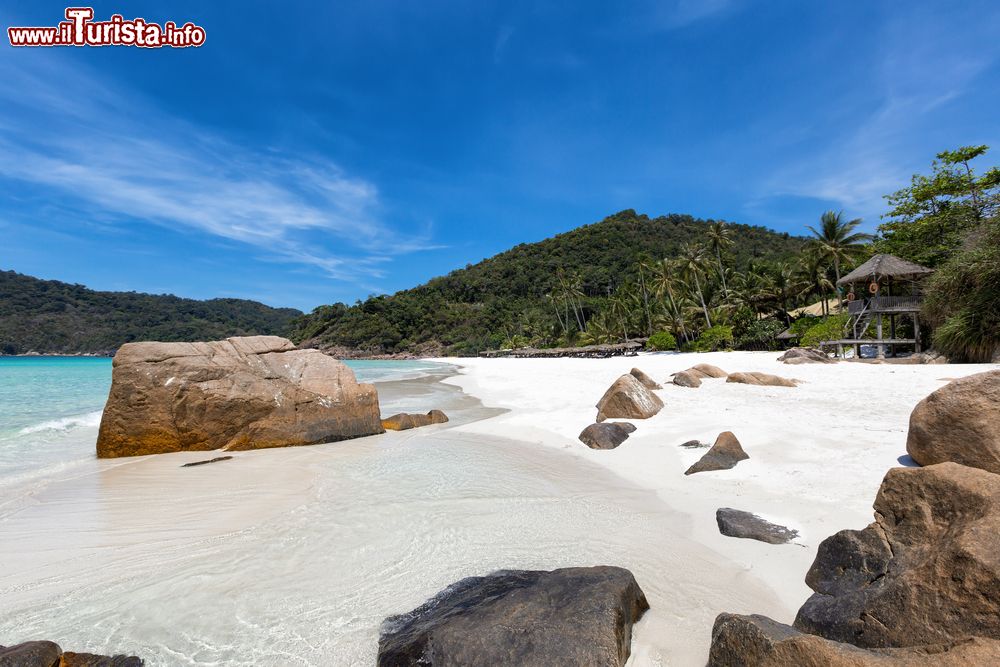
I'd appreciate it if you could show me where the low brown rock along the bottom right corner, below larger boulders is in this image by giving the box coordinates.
[708,614,1000,667]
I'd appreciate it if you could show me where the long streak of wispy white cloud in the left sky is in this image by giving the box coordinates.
[0,54,432,284]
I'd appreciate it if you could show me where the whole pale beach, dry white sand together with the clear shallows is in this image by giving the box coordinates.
[0,353,986,666]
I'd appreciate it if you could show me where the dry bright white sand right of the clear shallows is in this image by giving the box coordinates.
[434,352,997,665]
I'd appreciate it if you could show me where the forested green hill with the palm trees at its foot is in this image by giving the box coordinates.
[294,210,823,354]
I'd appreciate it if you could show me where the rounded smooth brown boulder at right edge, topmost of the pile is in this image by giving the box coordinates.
[906,371,1000,473]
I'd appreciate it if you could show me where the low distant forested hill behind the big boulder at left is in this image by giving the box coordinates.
[0,271,302,354]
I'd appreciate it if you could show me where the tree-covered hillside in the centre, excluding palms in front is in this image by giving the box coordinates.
[292,210,806,355]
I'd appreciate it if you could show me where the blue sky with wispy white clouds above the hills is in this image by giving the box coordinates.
[0,0,1000,310]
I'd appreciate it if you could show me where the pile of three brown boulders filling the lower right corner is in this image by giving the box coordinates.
[709,371,1000,667]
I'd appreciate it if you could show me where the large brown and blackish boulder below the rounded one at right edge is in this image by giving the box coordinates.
[795,463,1000,648]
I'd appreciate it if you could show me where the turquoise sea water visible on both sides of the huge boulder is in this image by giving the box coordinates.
[0,357,440,487]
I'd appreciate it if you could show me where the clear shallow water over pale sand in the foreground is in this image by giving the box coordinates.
[0,358,770,665]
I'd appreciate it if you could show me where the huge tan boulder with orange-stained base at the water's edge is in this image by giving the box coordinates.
[97,336,383,457]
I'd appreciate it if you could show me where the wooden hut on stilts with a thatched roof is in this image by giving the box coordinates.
[820,255,932,359]
